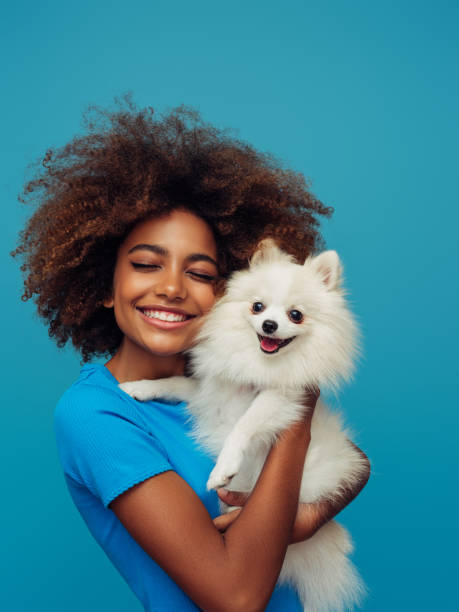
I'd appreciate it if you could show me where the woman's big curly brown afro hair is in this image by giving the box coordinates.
[12,97,332,361]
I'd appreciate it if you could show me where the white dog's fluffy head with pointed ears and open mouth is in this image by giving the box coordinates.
[194,241,357,386]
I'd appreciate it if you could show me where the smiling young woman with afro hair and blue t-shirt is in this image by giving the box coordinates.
[16,103,369,612]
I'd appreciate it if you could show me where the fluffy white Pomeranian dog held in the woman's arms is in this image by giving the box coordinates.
[120,239,367,612]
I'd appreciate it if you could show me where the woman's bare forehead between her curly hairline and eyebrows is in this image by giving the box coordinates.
[121,210,217,259]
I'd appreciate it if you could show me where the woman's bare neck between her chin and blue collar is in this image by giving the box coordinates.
[105,338,185,383]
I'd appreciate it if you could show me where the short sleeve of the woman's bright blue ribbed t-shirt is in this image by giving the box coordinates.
[54,385,173,507]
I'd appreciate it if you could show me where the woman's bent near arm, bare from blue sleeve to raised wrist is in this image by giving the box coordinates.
[110,396,313,612]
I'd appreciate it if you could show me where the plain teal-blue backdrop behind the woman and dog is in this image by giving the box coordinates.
[0,0,459,612]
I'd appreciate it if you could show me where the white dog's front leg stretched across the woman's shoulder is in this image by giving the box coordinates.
[119,376,197,402]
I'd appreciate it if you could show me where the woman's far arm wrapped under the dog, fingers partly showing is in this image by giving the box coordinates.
[214,440,370,544]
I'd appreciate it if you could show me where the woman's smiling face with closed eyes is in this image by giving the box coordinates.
[105,210,218,359]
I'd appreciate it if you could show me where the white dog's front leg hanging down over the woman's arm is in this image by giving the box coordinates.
[207,390,304,489]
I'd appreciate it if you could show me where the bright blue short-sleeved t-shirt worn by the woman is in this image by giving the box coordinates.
[55,364,302,612]
